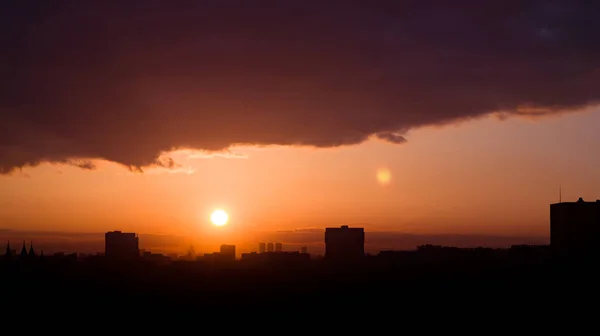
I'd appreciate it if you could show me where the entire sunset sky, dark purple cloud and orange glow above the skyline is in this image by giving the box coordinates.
[0,0,600,252]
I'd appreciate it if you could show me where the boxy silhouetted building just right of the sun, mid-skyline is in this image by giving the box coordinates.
[325,225,365,260]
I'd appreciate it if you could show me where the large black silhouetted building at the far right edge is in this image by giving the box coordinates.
[550,198,600,258]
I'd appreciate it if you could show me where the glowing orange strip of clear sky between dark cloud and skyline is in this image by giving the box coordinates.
[0,109,600,252]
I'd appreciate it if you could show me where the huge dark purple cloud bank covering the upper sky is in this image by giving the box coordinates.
[0,0,600,172]
